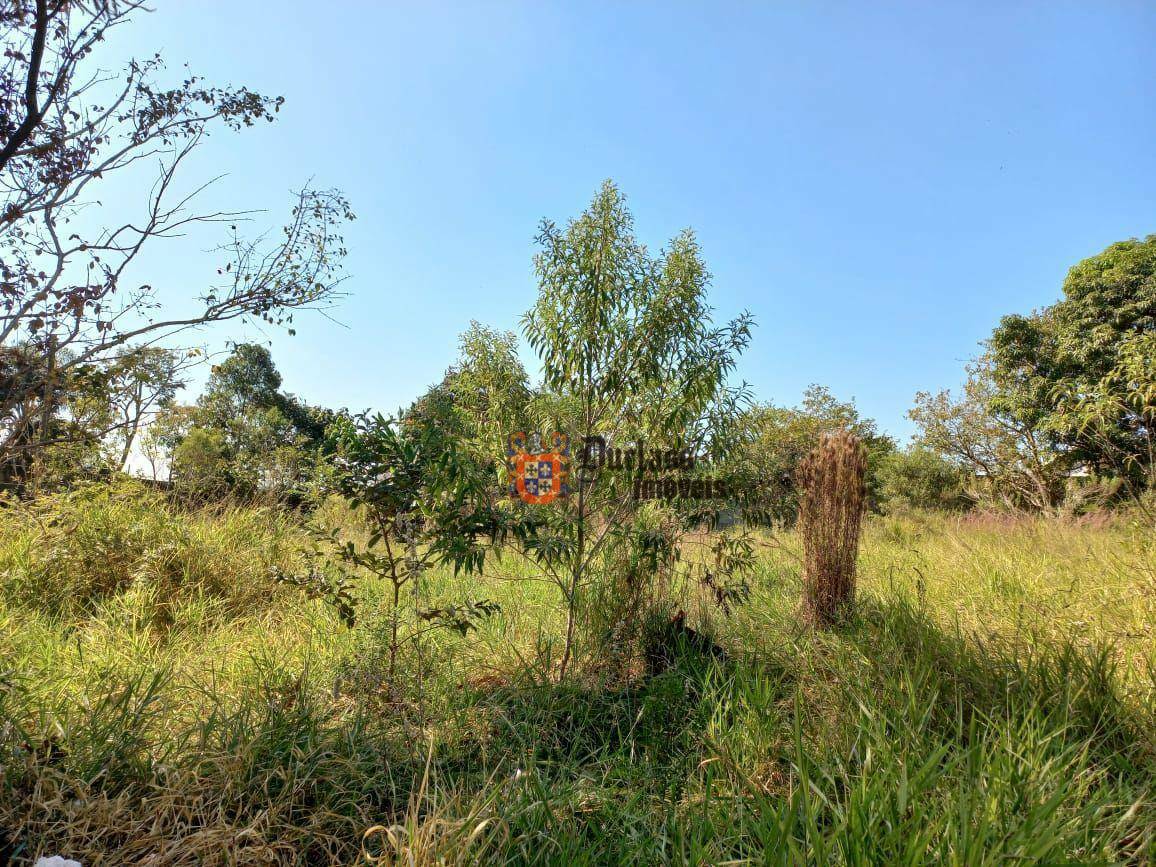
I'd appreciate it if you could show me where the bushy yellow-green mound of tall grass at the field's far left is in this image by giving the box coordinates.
[0,483,307,622]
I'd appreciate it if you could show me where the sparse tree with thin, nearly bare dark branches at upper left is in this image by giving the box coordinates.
[0,0,353,483]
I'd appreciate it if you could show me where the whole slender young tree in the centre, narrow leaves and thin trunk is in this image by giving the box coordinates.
[521,181,751,677]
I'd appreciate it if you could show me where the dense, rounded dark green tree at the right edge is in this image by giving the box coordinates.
[991,235,1156,490]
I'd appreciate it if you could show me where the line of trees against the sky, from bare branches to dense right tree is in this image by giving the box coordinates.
[0,6,1156,520]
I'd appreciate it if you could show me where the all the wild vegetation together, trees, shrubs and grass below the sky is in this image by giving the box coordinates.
[0,0,1156,867]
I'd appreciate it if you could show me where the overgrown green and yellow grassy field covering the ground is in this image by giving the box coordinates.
[0,489,1156,867]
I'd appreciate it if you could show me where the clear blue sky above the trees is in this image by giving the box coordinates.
[104,0,1156,437]
